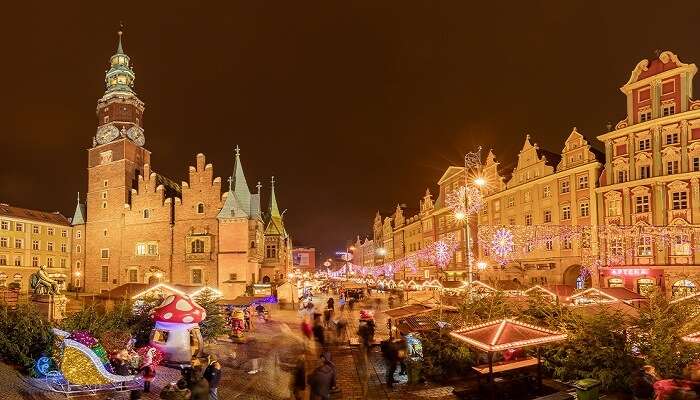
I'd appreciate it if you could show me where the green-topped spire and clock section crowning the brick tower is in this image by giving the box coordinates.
[93,29,146,146]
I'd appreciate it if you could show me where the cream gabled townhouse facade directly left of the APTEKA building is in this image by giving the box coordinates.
[478,133,602,285]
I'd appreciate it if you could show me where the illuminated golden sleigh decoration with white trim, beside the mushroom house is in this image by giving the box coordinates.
[36,329,143,397]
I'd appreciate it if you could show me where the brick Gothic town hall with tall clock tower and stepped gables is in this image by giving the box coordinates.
[71,32,292,299]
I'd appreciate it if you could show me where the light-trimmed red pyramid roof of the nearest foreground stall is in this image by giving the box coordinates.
[450,319,566,353]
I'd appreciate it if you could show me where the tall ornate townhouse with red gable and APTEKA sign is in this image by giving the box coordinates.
[597,51,700,296]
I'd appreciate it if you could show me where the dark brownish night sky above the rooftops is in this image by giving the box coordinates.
[0,0,700,258]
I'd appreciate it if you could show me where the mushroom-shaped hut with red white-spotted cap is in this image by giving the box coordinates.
[151,294,207,364]
